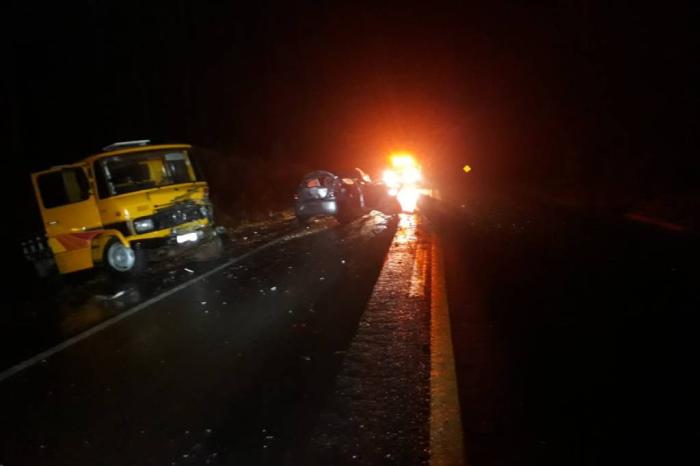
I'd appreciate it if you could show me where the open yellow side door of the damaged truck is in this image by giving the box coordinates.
[32,165,102,273]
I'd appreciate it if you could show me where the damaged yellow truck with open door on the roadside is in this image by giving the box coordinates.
[24,140,220,275]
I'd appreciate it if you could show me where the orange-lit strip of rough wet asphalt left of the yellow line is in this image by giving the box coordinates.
[305,214,431,465]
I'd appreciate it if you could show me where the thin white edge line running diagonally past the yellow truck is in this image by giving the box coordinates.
[0,230,321,383]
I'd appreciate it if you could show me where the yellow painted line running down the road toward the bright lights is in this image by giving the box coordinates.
[430,235,466,466]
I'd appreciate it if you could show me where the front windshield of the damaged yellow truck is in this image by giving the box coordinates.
[95,149,197,198]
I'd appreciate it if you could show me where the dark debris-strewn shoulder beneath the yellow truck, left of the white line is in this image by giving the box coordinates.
[0,215,304,374]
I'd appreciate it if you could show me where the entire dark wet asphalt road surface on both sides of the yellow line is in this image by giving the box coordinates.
[0,194,700,466]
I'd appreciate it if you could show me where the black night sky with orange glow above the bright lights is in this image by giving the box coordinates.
[2,0,700,201]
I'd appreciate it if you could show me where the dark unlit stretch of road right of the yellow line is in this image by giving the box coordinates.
[424,195,700,466]
